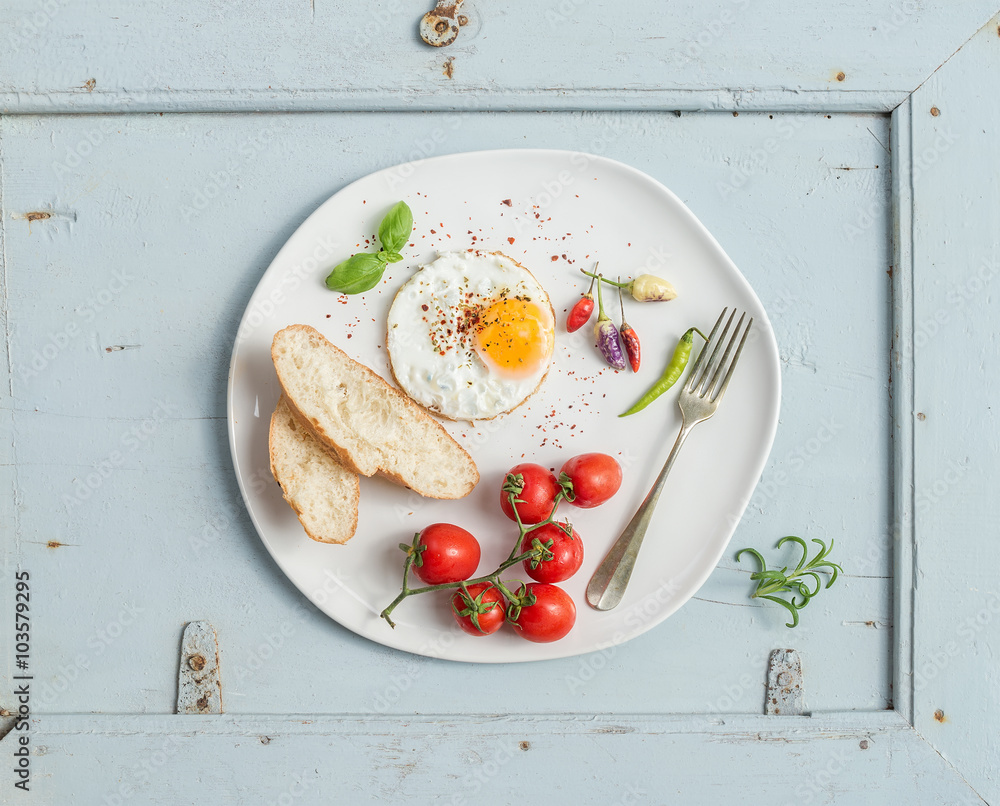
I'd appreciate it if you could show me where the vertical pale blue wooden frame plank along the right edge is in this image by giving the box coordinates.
[910,12,1000,802]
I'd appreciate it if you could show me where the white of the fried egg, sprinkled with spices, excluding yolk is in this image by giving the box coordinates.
[386,251,555,420]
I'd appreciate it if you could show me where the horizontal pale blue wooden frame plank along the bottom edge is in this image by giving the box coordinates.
[4,715,983,806]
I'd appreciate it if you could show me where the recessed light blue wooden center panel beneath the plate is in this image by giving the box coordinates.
[0,113,893,713]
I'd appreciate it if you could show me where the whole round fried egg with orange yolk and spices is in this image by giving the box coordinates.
[386,250,555,420]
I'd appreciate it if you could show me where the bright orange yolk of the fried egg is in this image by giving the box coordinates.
[475,299,555,375]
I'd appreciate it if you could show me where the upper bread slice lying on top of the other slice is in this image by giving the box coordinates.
[271,325,479,498]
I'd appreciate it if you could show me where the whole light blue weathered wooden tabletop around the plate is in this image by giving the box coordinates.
[0,0,1000,805]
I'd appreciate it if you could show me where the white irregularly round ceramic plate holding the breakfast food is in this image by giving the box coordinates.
[228,150,781,662]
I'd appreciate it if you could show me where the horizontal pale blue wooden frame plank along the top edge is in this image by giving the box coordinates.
[0,0,996,112]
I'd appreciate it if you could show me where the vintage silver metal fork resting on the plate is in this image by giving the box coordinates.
[587,307,753,610]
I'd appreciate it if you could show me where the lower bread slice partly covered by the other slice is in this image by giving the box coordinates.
[268,396,359,543]
